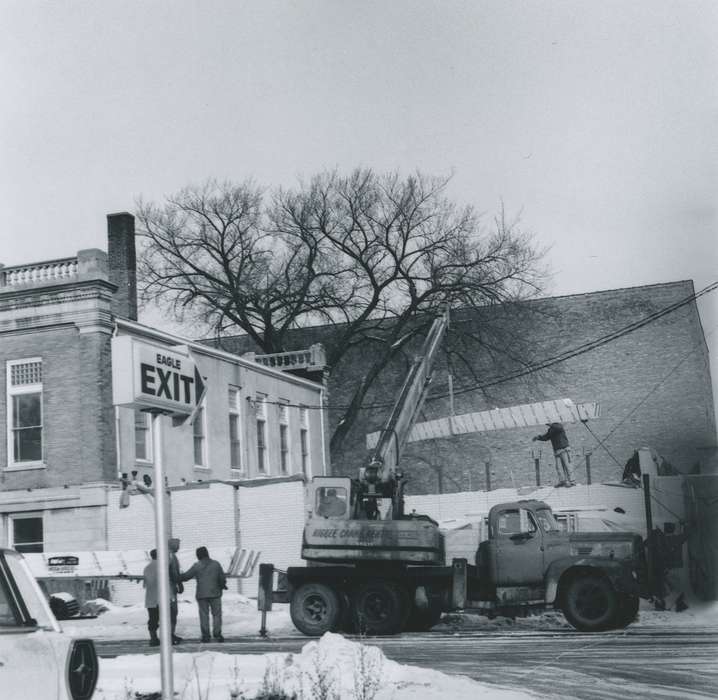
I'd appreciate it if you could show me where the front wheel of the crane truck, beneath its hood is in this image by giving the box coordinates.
[562,574,619,632]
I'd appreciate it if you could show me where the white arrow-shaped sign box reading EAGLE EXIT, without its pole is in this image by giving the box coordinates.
[112,335,205,415]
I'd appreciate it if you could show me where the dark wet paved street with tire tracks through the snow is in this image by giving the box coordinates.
[96,627,718,700]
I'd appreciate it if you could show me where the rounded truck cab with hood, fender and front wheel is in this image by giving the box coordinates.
[466,500,642,631]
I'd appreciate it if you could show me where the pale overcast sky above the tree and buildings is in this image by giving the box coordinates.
[0,0,718,400]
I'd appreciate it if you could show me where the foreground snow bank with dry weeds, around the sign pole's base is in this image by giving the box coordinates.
[95,634,533,700]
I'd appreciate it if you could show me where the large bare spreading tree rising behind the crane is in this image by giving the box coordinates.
[138,169,543,451]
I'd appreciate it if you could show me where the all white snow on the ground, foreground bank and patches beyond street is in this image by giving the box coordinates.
[62,594,718,700]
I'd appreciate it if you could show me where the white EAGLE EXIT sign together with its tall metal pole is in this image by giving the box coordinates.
[112,336,205,700]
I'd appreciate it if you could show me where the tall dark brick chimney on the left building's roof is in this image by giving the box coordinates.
[107,212,137,321]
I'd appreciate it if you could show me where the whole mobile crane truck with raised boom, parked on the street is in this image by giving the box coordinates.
[259,312,650,636]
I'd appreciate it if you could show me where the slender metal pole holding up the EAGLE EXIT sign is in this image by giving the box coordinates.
[152,412,174,700]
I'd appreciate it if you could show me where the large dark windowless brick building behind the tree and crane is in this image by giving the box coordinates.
[215,281,717,494]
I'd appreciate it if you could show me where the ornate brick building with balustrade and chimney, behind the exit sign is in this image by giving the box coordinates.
[0,213,326,552]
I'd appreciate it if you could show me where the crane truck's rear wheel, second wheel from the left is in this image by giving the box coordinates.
[352,580,409,635]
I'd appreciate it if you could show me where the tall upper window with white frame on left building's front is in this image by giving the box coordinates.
[6,357,43,468]
